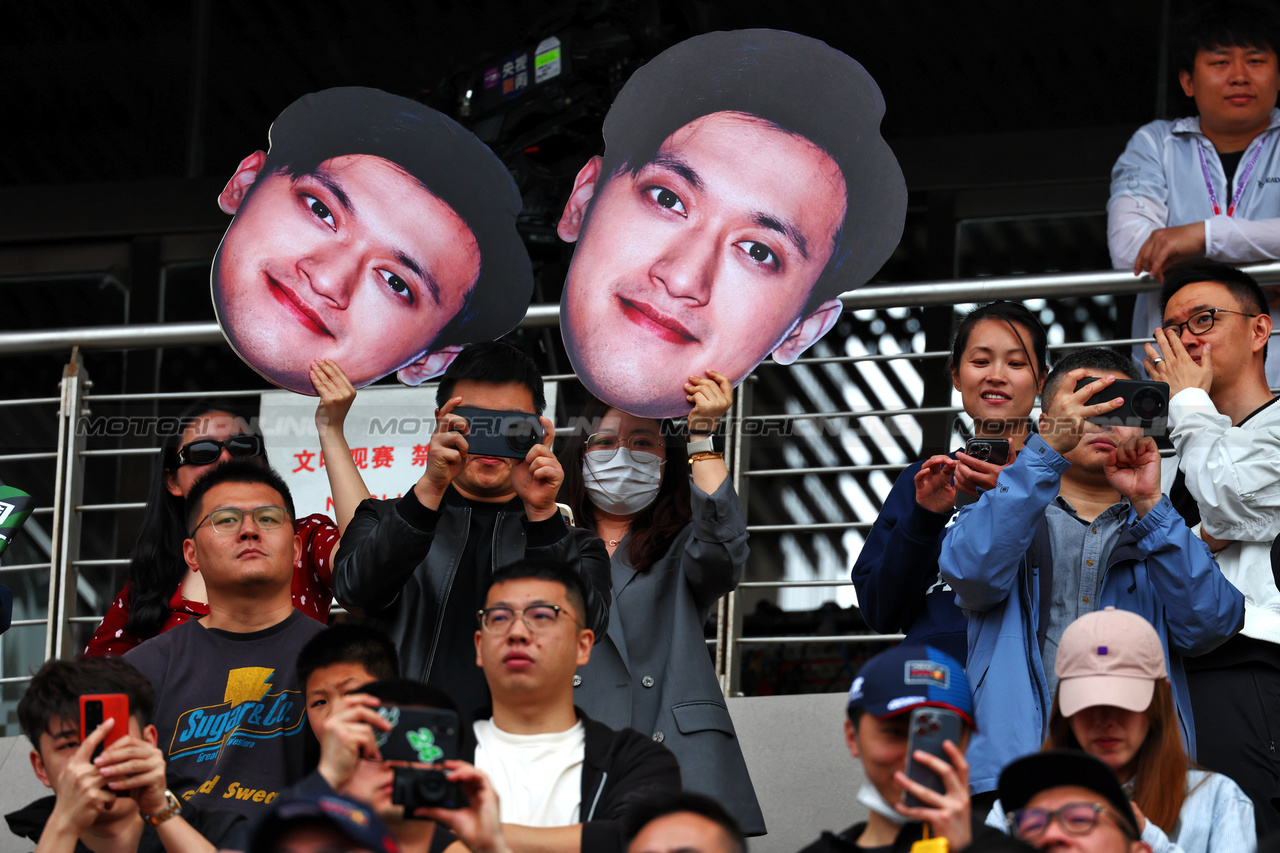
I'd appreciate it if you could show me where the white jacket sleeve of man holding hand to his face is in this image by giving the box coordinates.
[1169,388,1280,542]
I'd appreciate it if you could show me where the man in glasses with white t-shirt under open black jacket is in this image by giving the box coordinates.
[474,560,680,853]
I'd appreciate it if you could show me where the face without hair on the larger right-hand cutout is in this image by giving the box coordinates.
[559,111,847,418]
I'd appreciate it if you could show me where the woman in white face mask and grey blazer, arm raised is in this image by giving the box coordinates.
[559,370,764,835]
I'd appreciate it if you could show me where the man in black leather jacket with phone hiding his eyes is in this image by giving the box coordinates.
[333,342,611,720]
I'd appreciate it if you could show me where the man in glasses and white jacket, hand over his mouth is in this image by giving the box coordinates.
[1143,258,1280,836]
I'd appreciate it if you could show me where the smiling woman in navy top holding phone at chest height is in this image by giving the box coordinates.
[852,301,1048,661]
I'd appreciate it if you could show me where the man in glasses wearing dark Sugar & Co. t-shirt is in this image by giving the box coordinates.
[125,460,324,815]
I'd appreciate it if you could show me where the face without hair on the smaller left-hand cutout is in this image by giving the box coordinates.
[212,151,480,394]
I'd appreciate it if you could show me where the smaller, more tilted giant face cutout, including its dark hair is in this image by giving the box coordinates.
[212,88,534,394]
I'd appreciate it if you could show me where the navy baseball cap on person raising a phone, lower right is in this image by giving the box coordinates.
[849,646,978,731]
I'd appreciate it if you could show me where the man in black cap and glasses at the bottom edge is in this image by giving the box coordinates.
[1000,749,1151,853]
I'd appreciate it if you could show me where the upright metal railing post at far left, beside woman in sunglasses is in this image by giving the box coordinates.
[45,347,93,660]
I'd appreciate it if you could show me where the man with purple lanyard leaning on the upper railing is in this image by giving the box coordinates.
[1107,0,1280,383]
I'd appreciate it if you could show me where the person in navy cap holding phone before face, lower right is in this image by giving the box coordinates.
[801,644,983,853]
